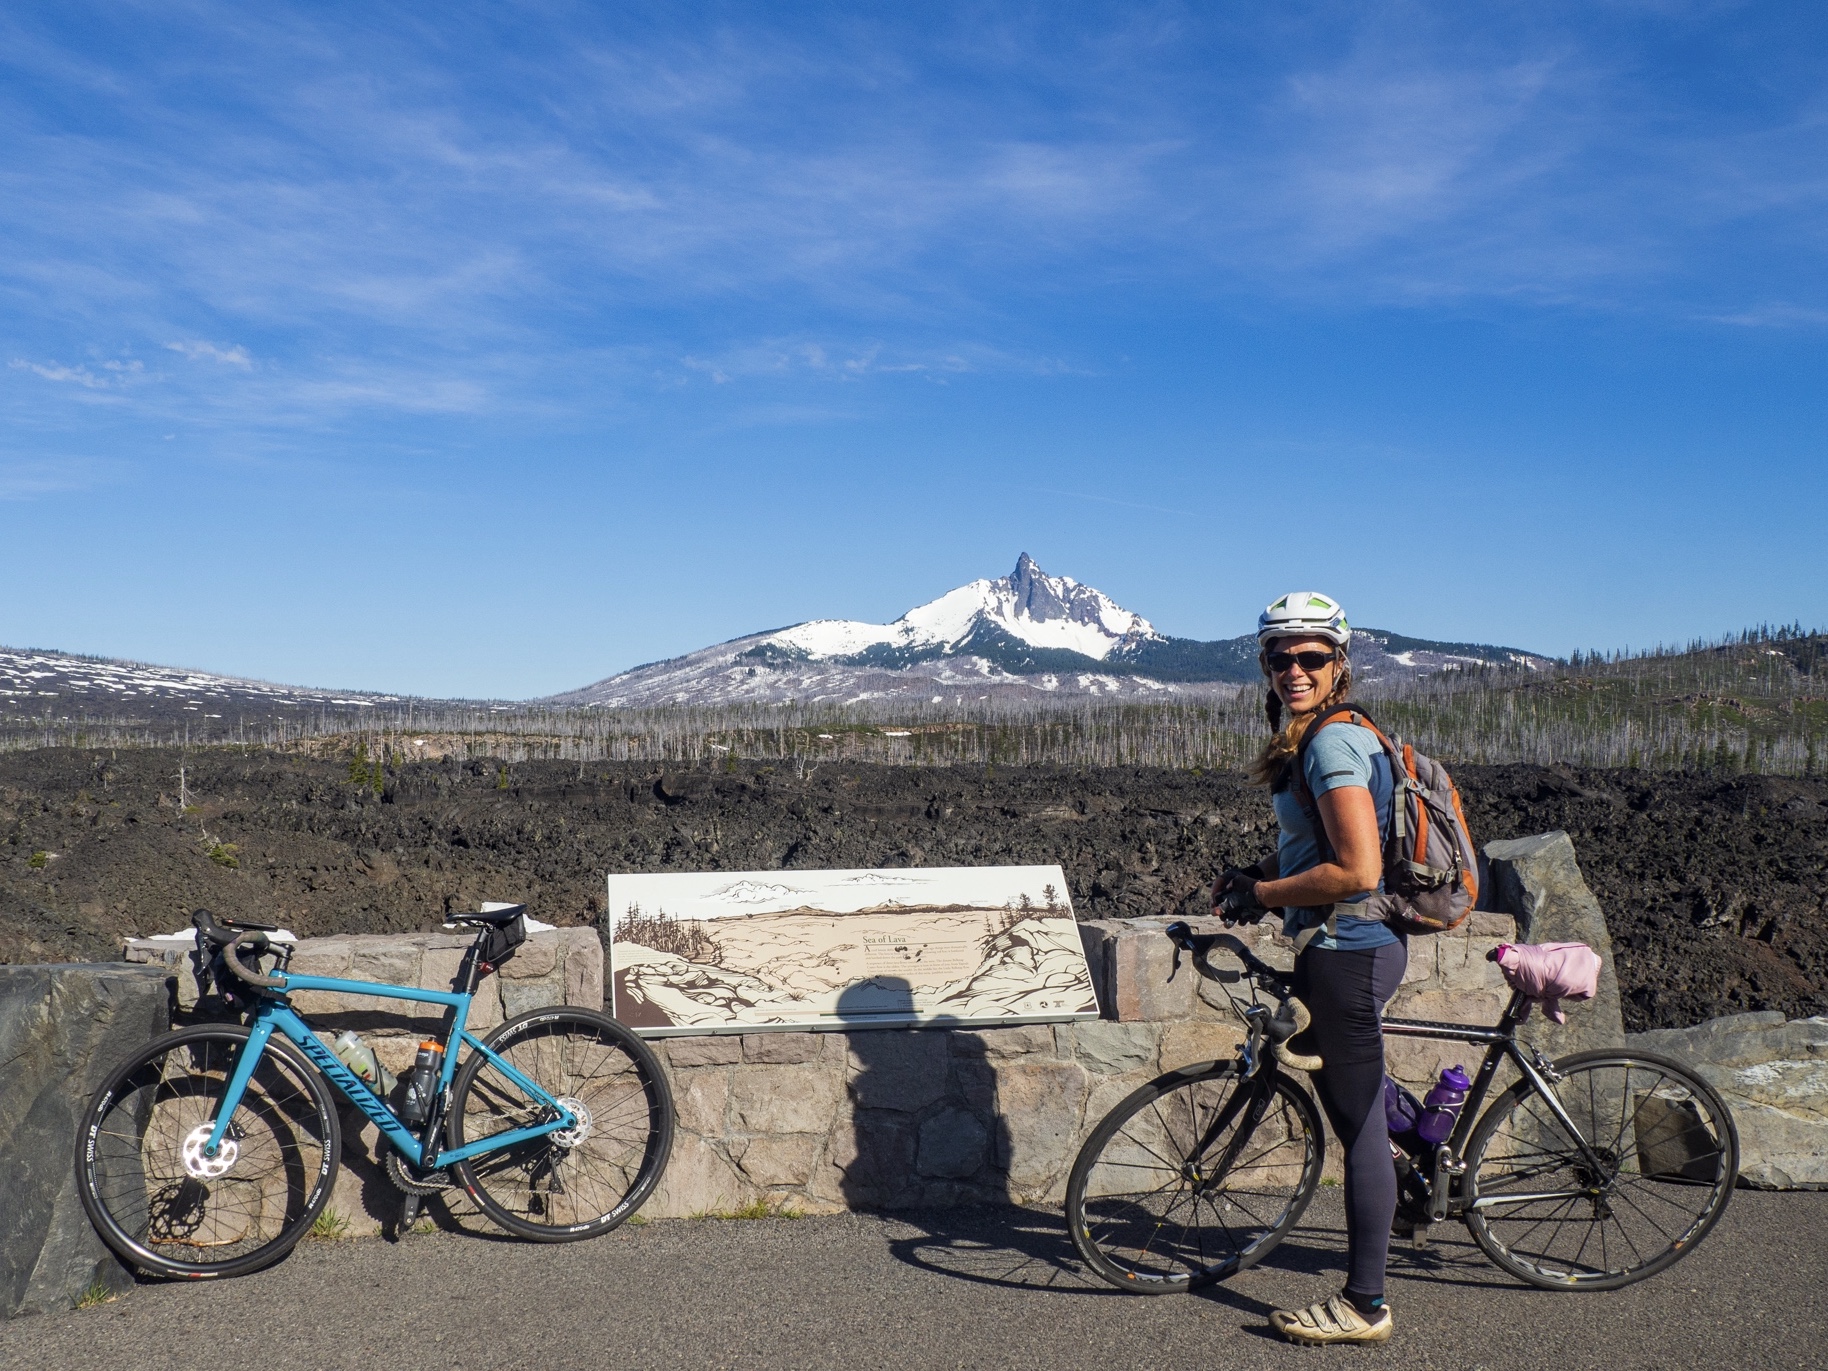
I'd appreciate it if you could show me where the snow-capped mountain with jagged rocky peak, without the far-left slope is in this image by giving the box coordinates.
[545,552,1546,707]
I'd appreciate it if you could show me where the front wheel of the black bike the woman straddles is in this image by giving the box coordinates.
[1066,1062,1327,1294]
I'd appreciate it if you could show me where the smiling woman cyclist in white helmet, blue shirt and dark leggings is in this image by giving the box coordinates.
[1212,590,1409,1344]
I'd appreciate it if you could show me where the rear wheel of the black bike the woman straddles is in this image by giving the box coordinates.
[1462,1051,1738,1291]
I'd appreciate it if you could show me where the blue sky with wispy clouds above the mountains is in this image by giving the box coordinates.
[0,0,1828,696]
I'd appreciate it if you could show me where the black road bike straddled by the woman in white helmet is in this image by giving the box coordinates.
[1066,923,1738,1294]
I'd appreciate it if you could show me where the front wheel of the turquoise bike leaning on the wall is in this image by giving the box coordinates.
[77,1024,342,1280]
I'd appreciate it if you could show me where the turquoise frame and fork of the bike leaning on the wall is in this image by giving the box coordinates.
[207,972,578,1170]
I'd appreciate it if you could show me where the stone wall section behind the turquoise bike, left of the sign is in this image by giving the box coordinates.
[126,929,603,1236]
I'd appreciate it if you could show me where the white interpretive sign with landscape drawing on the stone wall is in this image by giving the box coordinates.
[609,866,1099,1036]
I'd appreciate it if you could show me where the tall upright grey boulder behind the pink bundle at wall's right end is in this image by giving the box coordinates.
[1484,830,1625,1057]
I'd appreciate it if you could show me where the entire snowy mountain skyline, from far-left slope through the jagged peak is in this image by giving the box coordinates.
[0,552,1548,742]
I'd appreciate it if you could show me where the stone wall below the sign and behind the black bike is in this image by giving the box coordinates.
[643,914,1542,1217]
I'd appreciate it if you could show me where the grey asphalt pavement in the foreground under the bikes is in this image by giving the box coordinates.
[0,1190,1828,1371]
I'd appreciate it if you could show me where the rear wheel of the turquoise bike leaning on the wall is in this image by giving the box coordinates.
[450,1007,673,1243]
